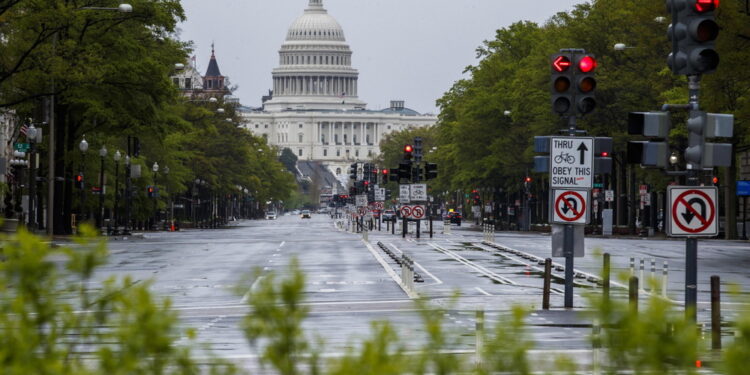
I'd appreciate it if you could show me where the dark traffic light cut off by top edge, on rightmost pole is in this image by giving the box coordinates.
[667,0,719,75]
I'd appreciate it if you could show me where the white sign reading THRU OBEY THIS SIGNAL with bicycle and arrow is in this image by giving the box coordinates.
[550,137,594,189]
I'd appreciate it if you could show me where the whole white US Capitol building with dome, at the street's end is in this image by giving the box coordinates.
[242,0,437,180]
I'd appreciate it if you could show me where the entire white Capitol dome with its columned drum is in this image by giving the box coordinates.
[264,0,366,111]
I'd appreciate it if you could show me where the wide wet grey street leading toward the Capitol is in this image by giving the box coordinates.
[85,215,750,374]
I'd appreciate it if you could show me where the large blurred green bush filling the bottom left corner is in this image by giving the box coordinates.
[0,227,235,375]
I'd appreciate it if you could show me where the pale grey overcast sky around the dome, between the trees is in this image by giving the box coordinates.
[180,0,584,113]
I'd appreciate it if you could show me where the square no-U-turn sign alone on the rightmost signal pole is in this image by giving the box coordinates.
[667,186,719,237]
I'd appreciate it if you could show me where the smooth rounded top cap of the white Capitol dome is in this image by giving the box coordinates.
[286,0,345,42]
